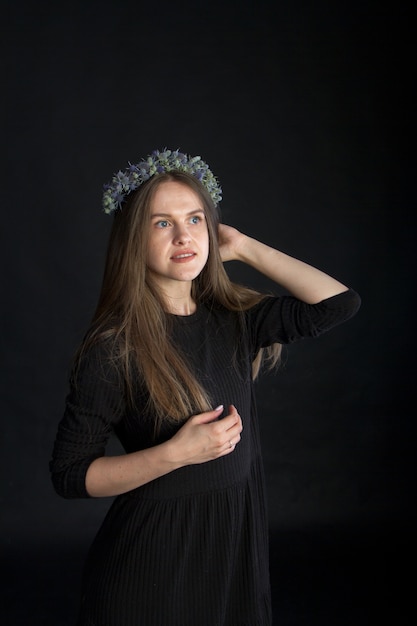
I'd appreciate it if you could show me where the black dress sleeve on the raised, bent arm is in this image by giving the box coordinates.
[248,289,361,353]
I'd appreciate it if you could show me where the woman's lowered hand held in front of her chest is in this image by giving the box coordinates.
[166,405,243,466]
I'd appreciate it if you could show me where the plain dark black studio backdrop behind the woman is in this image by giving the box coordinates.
[0,0,415,626]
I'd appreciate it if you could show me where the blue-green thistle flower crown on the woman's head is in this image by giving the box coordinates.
[103,148,222,213]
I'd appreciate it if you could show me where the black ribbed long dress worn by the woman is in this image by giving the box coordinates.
[50,290,360,626]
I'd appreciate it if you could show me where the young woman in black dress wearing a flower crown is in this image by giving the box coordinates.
[50,150,360,626]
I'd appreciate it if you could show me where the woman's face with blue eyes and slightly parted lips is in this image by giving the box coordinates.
[147,181,209,295]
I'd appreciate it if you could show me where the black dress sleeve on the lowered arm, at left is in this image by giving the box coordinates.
[49,338,125,498]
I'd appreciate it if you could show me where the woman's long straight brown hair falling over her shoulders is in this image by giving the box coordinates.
[76,171,281,429]
